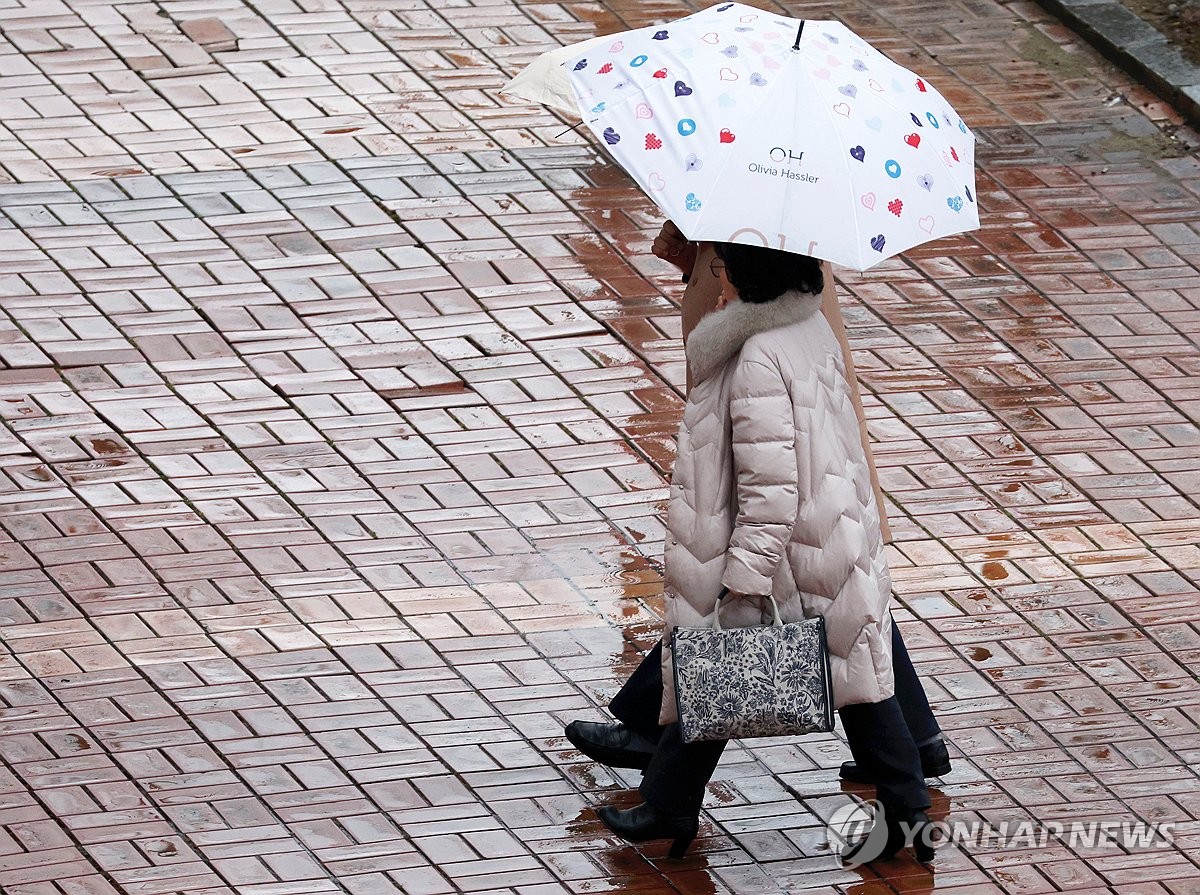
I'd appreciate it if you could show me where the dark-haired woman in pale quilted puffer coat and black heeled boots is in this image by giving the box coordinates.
[568,235,931,860]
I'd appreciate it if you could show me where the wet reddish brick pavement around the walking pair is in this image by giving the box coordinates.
[0,0,1200,895]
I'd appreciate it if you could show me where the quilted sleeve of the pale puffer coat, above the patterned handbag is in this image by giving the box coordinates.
[721,356,798,594]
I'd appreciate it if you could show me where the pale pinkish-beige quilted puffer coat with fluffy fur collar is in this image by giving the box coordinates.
[660,292,894,723]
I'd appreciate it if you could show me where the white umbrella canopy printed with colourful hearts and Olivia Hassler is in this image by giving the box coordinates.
[505,2,979,270]
